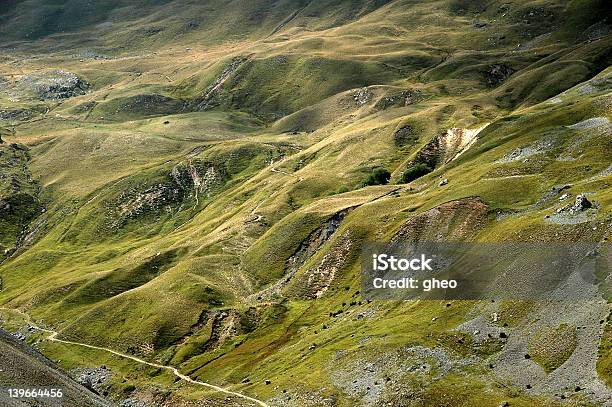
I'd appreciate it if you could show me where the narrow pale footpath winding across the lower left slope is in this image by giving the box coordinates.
[0,308,270,407]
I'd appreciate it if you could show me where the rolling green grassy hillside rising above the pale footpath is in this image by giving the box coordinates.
[0,0,612,406]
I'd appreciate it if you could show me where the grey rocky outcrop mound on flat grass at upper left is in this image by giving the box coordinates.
[17,70,89,100]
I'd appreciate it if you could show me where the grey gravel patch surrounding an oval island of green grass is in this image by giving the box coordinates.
[464,282,612,405]
